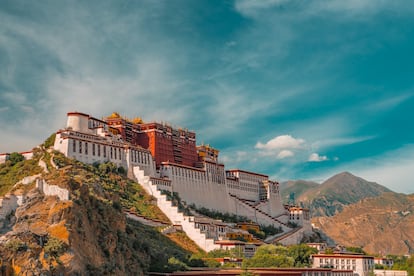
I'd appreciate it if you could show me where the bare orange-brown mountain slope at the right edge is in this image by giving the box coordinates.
[313,192,414,255]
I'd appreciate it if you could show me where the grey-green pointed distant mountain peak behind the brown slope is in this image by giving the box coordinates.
[288,172,391,217]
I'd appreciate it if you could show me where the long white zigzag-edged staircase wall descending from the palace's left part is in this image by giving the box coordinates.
[133,166,220,252]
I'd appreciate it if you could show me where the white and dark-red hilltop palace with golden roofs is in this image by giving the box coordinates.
[54,112,311,240]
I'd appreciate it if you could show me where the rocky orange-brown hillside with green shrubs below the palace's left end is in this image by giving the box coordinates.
[0,149,197,275]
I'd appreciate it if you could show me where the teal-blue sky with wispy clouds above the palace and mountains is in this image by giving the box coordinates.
[0,0,414,193]
